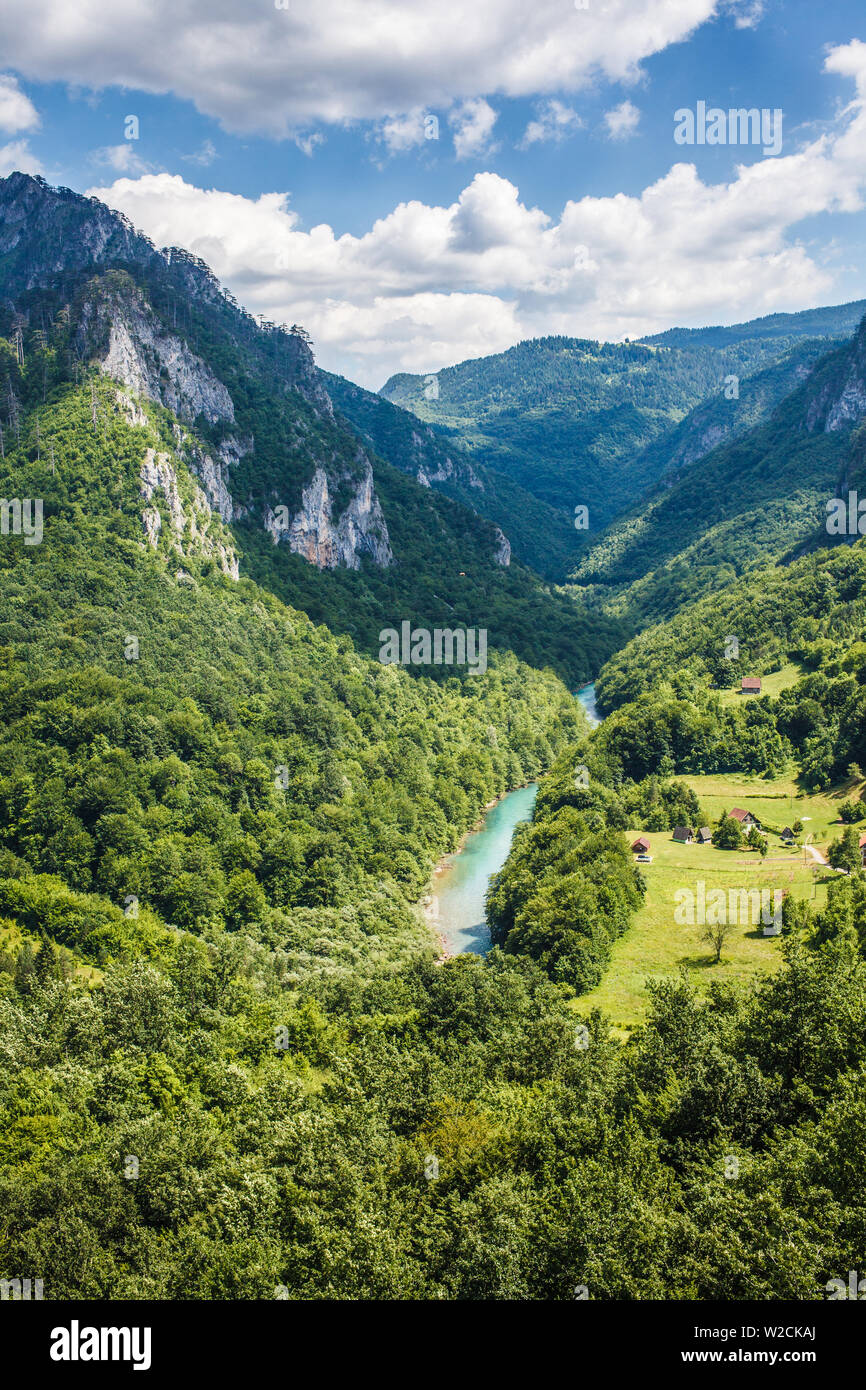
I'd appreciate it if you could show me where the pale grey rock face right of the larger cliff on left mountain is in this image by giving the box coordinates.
[264,463,393,570]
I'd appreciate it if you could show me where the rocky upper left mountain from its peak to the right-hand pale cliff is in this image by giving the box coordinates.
[0,174,393,573]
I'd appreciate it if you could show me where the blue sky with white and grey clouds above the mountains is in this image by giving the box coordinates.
[0,0,866,389]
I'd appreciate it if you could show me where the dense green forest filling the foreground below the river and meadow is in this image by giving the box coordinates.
[0,861,866,1300]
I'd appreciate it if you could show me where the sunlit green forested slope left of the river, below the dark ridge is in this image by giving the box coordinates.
[0,354,580,970]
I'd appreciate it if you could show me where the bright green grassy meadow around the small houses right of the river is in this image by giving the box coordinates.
[575,772,866,1031]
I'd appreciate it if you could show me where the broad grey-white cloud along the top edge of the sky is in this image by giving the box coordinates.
[0,0,727,135]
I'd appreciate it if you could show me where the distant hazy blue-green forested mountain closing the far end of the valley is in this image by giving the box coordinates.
[381,304,865,543]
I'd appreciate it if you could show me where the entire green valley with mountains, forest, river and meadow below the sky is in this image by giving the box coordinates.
[0,172,866,1302]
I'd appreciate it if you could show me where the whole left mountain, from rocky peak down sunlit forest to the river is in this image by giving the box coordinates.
[0,178,594,980]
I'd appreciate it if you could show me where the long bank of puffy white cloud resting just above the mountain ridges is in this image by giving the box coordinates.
[90,43,866,386]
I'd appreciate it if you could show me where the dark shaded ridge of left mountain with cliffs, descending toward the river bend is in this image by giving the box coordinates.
[0,174,624,684]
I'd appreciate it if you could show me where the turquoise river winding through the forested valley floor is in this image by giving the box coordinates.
[431,685,601,955]
